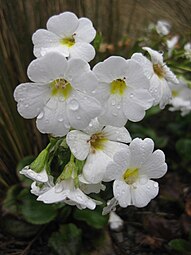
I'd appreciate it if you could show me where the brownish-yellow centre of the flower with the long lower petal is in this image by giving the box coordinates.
[88,133,108,153]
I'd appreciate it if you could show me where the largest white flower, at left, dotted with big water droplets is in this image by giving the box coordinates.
[14,53,101,136]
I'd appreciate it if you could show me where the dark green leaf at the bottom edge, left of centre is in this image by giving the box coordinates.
[48,224,81,255]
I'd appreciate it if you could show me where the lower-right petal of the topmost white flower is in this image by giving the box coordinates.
[69,42,95,62]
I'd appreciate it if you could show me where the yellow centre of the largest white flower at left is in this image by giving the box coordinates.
[50,79,72,99]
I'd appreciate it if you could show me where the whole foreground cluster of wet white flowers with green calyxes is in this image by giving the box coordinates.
[14,12,178,213]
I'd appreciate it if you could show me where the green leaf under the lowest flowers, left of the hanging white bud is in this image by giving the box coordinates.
[74,207,108,229]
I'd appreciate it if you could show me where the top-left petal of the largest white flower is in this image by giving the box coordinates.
[27,52,68,83]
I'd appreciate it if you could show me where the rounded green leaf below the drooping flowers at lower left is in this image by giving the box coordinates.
[18,189,57,225]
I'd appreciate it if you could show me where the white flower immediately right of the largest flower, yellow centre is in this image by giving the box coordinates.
[93,56,153,127]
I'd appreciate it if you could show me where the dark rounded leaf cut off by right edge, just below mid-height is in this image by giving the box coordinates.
[176,138,191,161]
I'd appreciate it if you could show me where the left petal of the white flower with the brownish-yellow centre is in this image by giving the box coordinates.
[66,130,90,160]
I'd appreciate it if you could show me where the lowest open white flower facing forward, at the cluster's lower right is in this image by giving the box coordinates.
[105,138,167,207]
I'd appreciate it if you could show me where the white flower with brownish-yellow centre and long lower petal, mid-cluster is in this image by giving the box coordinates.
[66,119,131,183]
